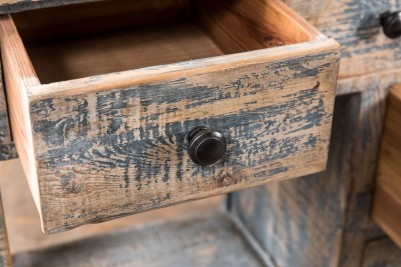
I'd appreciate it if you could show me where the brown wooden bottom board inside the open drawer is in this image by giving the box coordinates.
[25,22,223,84]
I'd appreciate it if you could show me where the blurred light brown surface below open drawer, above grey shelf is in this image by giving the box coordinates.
[0,160,225,255]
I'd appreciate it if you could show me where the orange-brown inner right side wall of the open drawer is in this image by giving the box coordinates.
[193,0,325,54]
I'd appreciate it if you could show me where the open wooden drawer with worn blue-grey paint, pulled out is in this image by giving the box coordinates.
[0,0,339,233]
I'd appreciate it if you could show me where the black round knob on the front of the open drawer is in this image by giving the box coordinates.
[188,126,227,166]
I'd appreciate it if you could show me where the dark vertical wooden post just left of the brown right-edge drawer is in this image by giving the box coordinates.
[340,86,389,266]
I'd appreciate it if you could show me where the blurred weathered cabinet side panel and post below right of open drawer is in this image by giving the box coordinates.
[233,85,394,267]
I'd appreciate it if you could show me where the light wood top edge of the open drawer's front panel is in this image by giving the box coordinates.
[27,39,340,101]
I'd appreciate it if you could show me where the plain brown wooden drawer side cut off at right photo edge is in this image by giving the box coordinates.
[372,85,401,247]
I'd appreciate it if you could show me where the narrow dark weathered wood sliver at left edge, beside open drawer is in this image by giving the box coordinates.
[0,56,17,161]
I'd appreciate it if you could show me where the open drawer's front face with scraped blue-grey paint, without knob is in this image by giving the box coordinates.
[30,46,339,232]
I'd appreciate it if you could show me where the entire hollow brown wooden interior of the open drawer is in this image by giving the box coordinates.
[13,0,319,84]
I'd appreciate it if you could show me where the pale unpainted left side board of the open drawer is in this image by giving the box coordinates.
[0,15,40,224]
